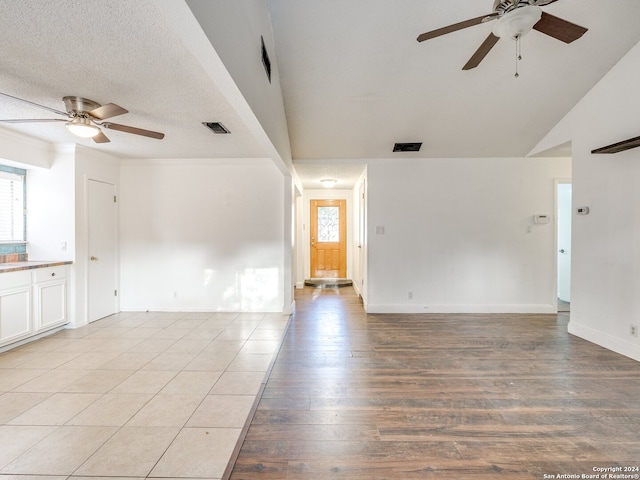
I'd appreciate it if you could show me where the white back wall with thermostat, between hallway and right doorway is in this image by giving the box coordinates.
[365,158,571,313]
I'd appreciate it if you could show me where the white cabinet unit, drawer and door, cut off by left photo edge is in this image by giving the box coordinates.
[0,271,33,346]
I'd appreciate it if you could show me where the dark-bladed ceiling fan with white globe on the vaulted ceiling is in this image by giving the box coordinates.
[418,0,588,71]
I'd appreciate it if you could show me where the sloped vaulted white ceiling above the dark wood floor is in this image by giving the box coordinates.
[269,0,640,159]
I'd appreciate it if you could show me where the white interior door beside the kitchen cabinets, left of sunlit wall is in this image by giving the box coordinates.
[87,180,117,322]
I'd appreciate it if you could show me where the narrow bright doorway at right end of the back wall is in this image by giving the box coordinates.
[556,180,571,312]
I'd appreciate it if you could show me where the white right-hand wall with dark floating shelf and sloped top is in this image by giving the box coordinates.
[536,39,640,360]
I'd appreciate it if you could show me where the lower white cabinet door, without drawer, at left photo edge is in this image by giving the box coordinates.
[0,285,31,344]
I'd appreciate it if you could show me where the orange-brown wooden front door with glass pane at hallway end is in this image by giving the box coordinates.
[310,200,347,278]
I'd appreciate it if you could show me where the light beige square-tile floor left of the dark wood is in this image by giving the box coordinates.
[0,312,289,480]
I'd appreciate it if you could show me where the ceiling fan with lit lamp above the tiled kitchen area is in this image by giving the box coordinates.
[0,92,164,143]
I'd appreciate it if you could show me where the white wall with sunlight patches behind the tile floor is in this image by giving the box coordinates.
[120,159,284,312]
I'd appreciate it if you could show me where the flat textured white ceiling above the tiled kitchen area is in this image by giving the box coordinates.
[0,0,264,158]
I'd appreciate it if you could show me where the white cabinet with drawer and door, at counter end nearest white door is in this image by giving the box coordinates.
[33,266,67,333]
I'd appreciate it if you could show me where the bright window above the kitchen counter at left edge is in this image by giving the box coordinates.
[0,165,27,243]
